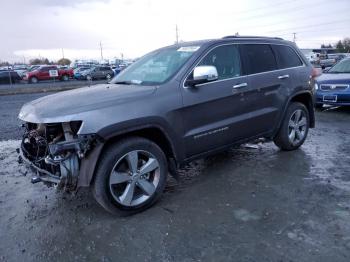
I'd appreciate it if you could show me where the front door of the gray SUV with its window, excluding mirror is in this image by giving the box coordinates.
[181,44,249,157]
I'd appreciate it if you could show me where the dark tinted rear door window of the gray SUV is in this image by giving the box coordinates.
[241,44,277,74]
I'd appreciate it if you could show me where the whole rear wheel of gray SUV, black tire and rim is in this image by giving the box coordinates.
[274,102,310,151]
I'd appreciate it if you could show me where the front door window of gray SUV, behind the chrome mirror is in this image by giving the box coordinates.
[198,45,241,80]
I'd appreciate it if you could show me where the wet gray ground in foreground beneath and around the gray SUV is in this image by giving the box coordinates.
[0,105,350,262]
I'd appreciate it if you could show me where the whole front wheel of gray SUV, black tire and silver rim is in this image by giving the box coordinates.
[92,137,168,215]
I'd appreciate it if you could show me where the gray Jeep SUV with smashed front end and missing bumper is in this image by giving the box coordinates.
[19,36,315,214]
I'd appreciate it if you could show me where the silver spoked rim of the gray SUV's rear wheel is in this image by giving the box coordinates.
[288,109,307,145]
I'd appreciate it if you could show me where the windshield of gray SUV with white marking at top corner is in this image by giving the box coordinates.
[111,46,200,85]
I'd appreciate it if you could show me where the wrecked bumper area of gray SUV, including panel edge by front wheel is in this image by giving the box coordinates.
[17,126,103,191]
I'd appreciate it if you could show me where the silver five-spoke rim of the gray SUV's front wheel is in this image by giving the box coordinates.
[109,150,160,206]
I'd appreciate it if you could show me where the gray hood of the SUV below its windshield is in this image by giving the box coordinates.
[18,84,156,123]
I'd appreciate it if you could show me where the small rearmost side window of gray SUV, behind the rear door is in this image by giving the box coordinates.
[273,45,303,69]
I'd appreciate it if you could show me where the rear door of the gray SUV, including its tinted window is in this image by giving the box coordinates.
[241,43,290,136]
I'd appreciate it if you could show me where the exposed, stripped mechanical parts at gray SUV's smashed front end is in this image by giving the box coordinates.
[18,121,100,191]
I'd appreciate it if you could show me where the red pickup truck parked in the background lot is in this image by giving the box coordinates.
[23,65,74,83]
